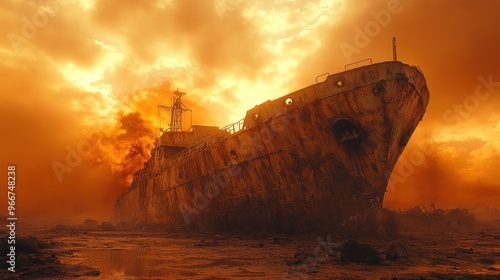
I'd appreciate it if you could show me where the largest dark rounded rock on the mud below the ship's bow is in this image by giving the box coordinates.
[340,240,380,264]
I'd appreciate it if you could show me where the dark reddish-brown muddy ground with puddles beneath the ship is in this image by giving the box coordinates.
[0,209,500,279]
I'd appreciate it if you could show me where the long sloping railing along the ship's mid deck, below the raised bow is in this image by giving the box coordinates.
[165,119,245,168]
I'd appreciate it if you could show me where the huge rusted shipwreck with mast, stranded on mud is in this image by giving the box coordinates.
[115,61,429,232]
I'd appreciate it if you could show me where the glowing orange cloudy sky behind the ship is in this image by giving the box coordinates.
[0,0,500,220]
